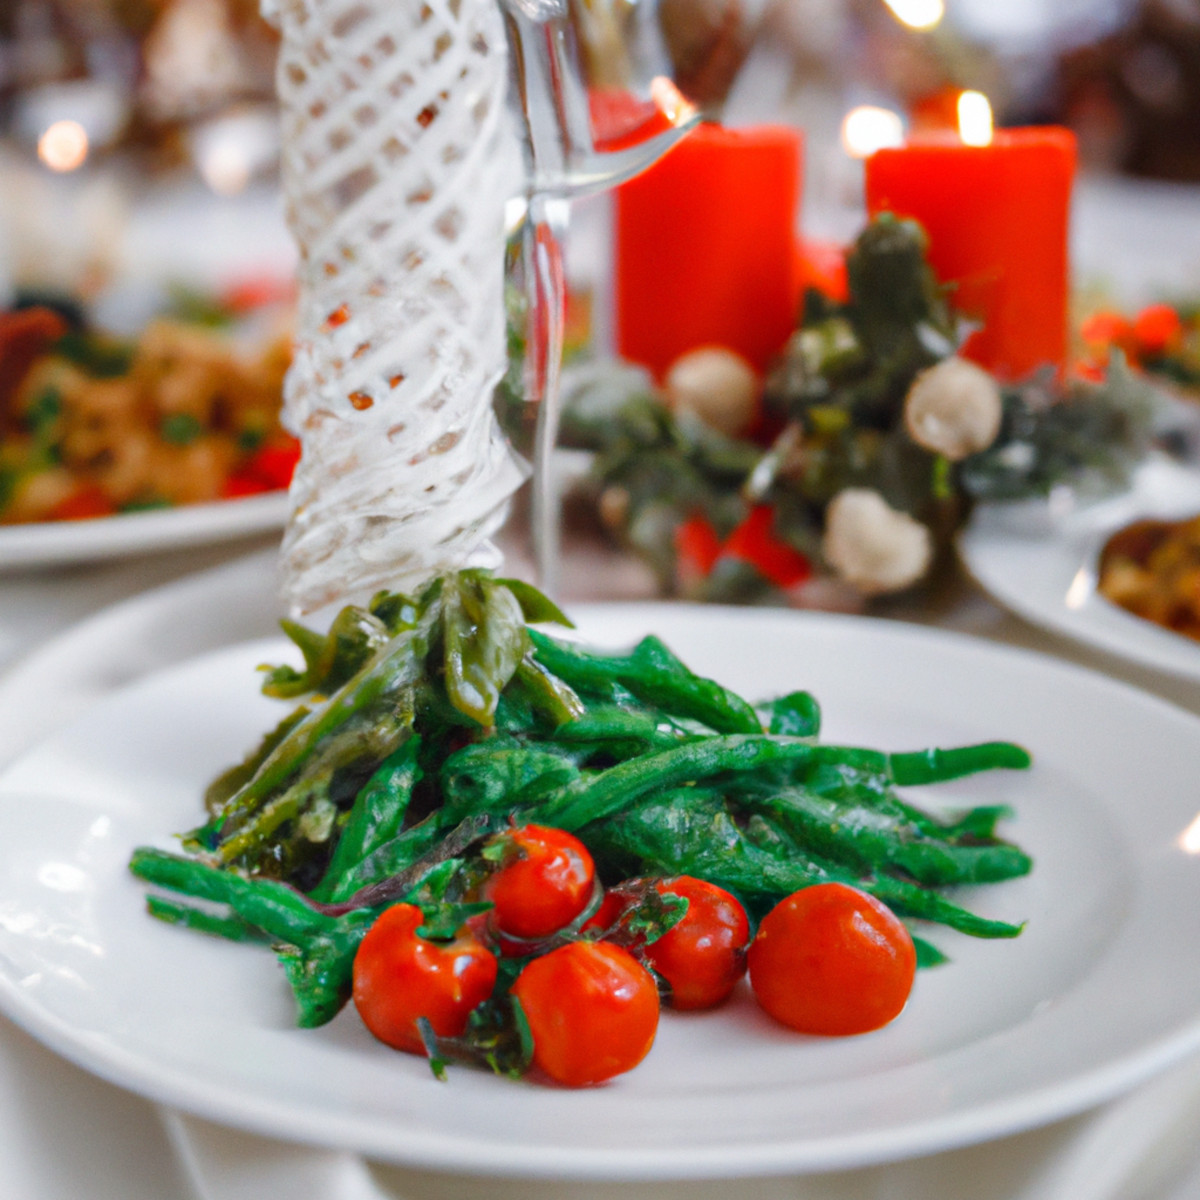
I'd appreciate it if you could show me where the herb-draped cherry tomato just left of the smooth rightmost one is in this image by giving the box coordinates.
[646,875,750,1009]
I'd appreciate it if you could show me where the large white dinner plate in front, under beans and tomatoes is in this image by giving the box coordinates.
[0,605,1200,1180]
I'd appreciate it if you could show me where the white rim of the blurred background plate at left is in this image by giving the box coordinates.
[0,492,288,571]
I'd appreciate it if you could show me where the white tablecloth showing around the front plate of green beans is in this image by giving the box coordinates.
[0,523,1200,1200]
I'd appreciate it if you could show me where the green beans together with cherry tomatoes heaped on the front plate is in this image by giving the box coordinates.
[131,570,1032,1086]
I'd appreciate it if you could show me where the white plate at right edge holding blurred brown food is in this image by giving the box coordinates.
[959,457,1200,682]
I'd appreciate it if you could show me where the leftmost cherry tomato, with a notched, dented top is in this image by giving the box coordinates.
[354,904,497,1054]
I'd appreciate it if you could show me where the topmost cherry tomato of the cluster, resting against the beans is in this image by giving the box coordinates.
[484,824,595,940]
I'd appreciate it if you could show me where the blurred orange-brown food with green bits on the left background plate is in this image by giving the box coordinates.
[0,306,299,523]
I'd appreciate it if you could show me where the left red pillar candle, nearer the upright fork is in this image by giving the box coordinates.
[613,125,803,378]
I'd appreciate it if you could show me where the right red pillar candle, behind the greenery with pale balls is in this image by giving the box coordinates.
[866,127,1075,379]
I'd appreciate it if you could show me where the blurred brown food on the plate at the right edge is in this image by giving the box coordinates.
[1097,516,1200,641]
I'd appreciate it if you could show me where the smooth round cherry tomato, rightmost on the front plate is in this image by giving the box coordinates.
[749,883,917,1036]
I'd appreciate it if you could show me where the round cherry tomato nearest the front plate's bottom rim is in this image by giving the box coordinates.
[512,942,659,1087]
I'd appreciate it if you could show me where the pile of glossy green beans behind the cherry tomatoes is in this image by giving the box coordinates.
[130,570,1032,1026]
